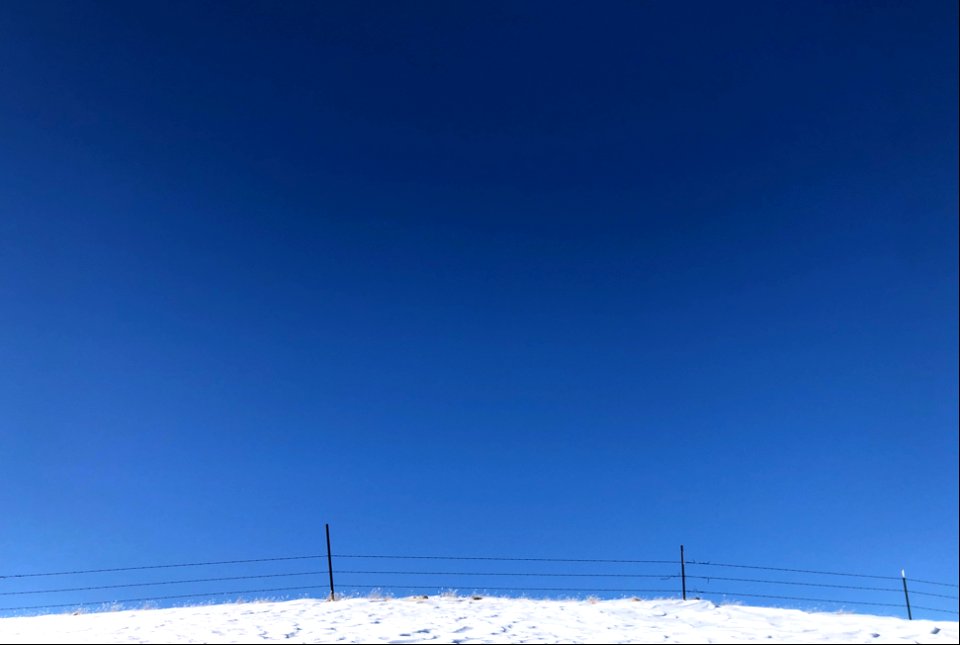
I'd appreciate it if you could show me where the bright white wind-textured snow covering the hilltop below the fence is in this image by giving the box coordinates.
[0,596,958,643]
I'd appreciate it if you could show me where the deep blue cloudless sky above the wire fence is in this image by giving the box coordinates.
[0,1,958,612]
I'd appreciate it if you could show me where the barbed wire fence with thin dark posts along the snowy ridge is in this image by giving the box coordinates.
[0,529,960,619]
